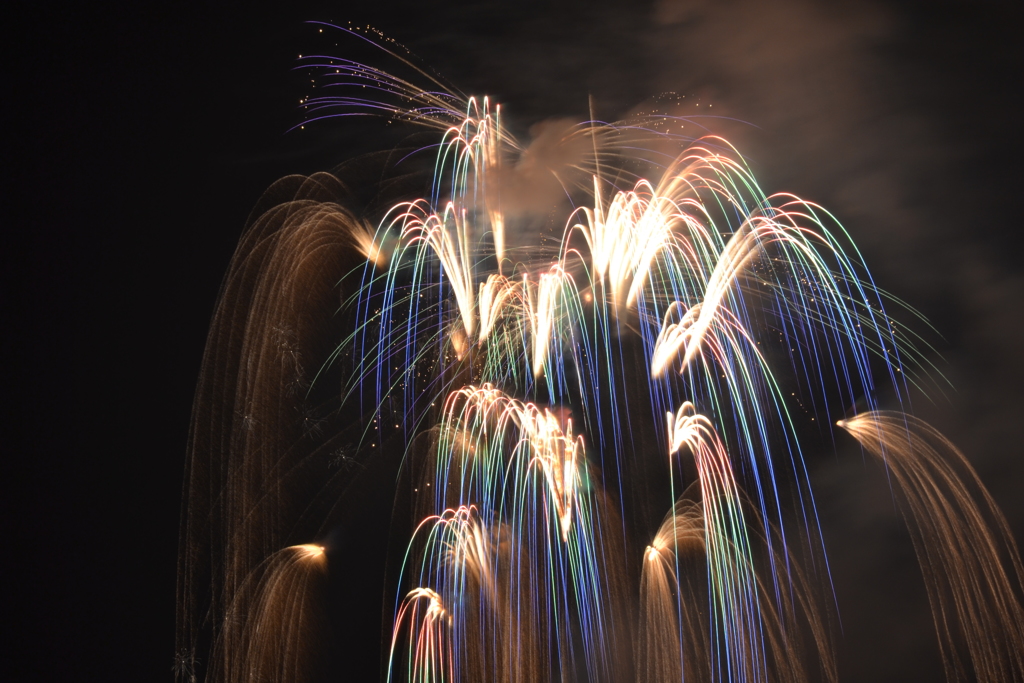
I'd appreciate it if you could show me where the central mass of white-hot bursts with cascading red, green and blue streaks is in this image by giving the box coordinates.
[340,92,915,683]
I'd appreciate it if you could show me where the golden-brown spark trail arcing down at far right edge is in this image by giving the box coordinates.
[837,411,1024,681]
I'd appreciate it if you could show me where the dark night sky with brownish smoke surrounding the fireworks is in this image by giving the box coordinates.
[8,0,1024,681]
